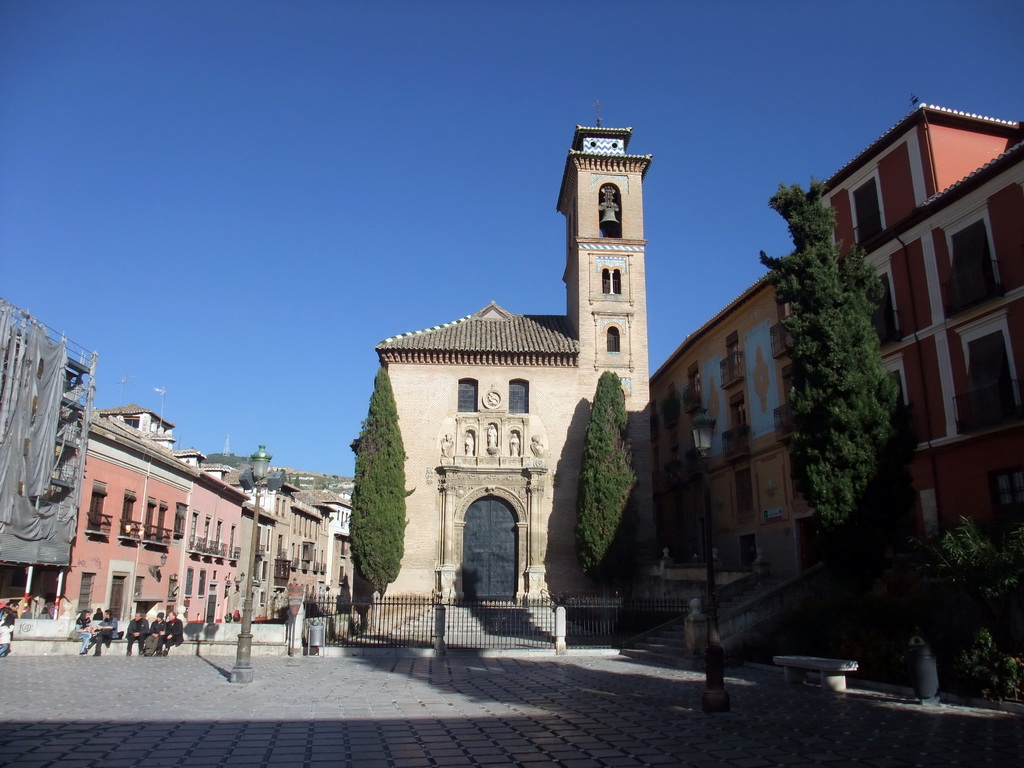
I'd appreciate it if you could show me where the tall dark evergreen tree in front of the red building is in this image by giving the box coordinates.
[761,181,914,579]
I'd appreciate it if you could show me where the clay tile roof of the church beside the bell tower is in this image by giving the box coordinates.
[377,302,580,354]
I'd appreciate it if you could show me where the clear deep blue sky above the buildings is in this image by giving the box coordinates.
[0,0,1024,474]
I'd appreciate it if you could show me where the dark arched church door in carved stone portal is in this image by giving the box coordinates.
[462,497,516,600]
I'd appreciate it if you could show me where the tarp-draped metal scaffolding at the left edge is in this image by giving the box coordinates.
[0,299,97,566]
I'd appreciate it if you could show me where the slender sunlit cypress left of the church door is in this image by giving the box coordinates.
[350,368,409,594]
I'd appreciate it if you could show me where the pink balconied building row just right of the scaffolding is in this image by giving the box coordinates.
[65,406,246,622]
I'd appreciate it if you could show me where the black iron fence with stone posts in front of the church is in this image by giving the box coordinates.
[306,596,688,650]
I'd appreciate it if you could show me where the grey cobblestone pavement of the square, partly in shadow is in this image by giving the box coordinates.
[0,645,1024,768]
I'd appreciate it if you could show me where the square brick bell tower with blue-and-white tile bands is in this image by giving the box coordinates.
[558,126,651,382]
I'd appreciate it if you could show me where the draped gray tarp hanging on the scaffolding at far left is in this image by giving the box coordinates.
[0,300,78,563]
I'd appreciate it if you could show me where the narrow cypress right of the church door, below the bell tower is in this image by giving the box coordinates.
[575,371,637,580]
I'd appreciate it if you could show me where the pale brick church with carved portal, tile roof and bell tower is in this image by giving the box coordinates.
[377,126,653,599]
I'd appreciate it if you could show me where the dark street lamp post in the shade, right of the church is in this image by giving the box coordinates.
[693,409,729,713]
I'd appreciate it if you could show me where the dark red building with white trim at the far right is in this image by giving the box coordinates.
[826,104,1024,535]
